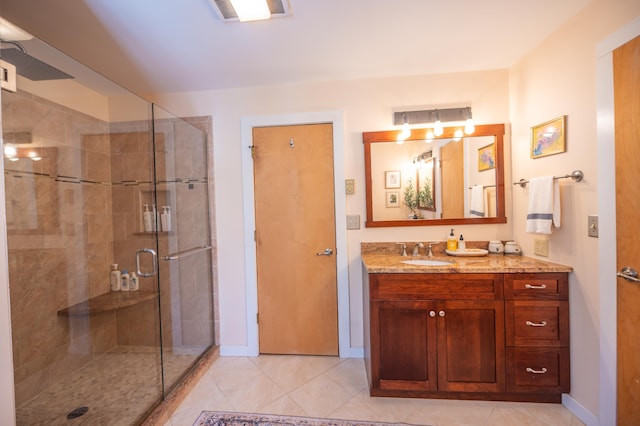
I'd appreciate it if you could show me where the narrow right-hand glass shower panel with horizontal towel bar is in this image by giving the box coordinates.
[151,105,214,392]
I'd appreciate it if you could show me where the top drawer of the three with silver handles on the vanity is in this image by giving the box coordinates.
[504,273,569,300]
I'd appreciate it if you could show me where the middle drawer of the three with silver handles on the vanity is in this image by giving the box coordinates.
[505,300,569,347]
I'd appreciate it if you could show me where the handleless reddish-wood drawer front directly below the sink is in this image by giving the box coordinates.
[369,274,503,300]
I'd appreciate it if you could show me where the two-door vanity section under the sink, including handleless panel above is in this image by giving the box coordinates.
[365,274,505,396]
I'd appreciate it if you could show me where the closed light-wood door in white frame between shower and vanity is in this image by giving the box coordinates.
[253,124,338,355]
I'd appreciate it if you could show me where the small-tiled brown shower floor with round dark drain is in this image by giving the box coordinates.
[16,347,197,426]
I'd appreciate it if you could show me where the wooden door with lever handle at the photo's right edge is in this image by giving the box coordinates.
[613,37,640,426]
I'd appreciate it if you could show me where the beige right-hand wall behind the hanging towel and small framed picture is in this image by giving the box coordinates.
[510,0,640,416]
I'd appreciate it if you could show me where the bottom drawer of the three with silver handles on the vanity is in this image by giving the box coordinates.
[507,348,571,392]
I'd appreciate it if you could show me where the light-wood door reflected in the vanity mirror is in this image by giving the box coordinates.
[440,141,465,219]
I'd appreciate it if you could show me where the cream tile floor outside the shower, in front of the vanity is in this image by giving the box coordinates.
[164,355,583,426]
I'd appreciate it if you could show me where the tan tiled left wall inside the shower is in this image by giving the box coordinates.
[2,92,117,406]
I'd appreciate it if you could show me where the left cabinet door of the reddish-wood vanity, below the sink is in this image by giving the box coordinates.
[371,301,437,391]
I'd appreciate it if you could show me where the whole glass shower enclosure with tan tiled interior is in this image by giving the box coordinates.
[0,16,215,425]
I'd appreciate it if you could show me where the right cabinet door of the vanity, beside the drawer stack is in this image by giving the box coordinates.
[437,300,505,392]
